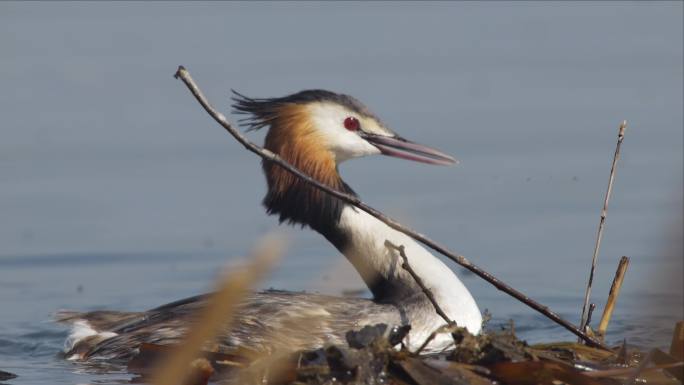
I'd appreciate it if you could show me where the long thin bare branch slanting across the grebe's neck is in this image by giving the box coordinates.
[174,66,608,350]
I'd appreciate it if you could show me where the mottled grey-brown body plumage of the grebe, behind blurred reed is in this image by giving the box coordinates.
[62,290,400,360]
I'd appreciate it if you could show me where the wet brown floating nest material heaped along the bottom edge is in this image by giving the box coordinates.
[120,322,683,385]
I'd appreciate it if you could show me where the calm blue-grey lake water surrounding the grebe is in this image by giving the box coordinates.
[0,2,684,385]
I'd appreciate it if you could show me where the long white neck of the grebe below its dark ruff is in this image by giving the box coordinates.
[338,206,482,333]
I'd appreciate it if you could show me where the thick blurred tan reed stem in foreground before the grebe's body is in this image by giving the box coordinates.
[150,238,283,385]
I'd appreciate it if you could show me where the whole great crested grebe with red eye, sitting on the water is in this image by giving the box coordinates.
[59,90,482,360]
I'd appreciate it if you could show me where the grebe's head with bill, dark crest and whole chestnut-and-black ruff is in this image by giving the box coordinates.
[233,90,456,234]
